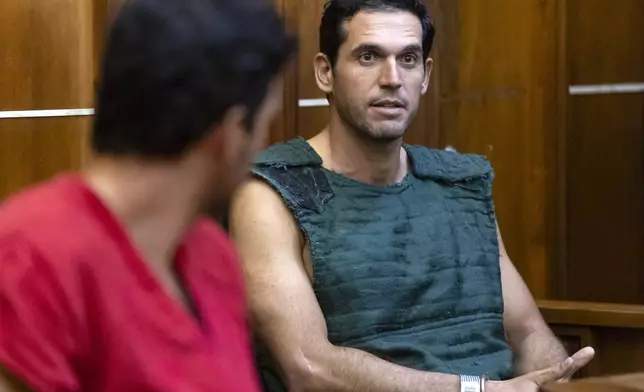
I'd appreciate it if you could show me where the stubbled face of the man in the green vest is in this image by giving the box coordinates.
[316,11,431,141]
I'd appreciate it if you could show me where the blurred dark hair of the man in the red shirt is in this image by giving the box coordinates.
[92,0,296,158]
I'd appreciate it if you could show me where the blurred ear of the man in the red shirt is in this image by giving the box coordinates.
[203,105,250,165]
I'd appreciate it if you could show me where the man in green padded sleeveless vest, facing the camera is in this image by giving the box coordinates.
[229,0,594,392]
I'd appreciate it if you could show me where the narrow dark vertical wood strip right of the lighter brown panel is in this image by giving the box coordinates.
[550,0,570,299]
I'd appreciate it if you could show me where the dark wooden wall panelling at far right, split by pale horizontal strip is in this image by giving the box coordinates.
[566,0,644,303]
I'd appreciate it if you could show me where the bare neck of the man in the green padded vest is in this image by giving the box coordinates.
[310,114,409,185]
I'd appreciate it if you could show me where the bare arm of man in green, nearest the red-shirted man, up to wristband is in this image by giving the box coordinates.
[230,180,460,392]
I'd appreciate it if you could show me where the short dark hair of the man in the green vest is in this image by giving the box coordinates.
[320,0,435,66]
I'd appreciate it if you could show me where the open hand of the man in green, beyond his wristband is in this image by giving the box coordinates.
[488,347,595,392]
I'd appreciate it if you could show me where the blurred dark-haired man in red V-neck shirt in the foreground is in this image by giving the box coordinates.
[0,0,295,392]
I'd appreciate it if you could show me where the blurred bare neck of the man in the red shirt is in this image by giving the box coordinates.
[85,158,200,269]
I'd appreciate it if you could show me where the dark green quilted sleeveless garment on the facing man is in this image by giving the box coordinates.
[253,139,512,392]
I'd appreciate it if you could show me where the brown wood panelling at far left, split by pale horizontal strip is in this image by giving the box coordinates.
[0,0,96,199]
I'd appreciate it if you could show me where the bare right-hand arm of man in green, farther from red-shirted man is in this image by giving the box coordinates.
[498,228,594,379]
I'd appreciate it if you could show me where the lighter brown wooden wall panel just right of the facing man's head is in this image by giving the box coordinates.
[432,0,558,298]
